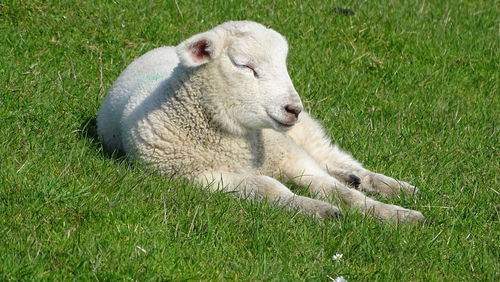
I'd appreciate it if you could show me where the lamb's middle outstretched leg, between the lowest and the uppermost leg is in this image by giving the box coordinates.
[281,152,425,222]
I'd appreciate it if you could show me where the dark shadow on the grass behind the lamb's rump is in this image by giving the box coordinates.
[78,116,126,162]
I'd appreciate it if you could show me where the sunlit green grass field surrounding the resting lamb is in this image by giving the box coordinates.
[0,0,500,281]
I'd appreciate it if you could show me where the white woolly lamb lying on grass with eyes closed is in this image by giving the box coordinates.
[97,21,425,222]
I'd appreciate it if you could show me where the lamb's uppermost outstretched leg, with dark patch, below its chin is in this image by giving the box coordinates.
[286,113,419,196]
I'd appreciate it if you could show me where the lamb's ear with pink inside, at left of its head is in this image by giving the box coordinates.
[176,31,222,67]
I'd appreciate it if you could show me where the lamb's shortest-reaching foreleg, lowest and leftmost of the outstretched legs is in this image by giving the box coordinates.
[195,172,341,218]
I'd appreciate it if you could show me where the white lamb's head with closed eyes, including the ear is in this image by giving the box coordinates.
[177,21,302,134]
